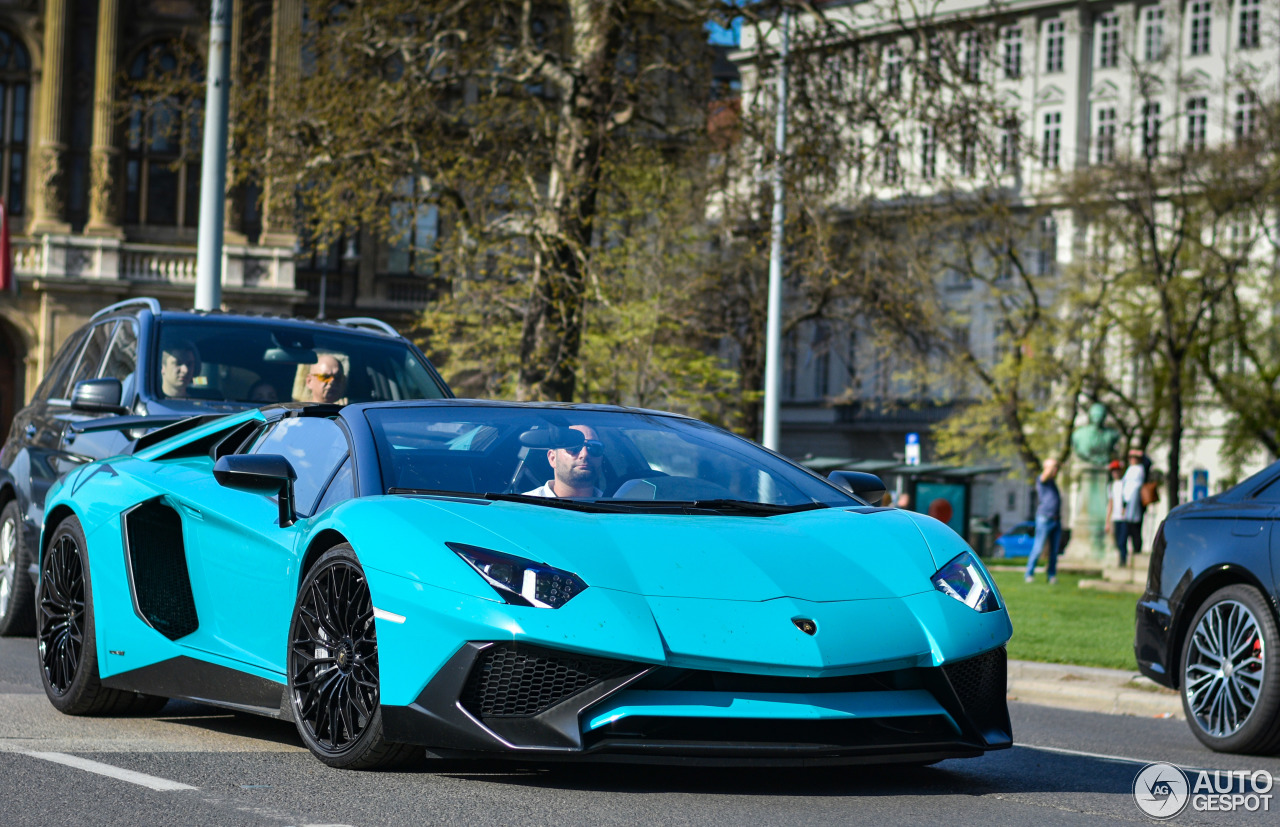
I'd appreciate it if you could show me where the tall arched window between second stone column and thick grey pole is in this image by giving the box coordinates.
[124,42,204,228]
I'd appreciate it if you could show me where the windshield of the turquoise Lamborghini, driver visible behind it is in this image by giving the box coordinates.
[365,406,861,510]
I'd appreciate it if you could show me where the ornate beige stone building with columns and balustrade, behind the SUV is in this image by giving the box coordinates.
[0,0,436,440]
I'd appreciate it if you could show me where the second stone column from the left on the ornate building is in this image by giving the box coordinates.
[84,0,124,238]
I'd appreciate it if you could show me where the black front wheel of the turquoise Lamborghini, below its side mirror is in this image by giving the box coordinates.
[288,543,422,769]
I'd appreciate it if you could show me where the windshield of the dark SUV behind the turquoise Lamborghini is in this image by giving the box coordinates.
[151,319,445,405]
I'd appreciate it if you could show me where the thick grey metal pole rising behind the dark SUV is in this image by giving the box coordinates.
[196,0,232,310]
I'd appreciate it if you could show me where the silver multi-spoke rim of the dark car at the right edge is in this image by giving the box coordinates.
[1183,600,1266,737]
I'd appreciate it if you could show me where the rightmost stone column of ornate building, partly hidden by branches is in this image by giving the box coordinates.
[261,0,302,250]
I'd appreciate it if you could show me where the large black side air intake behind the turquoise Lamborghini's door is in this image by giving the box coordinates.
[124,499,200,640]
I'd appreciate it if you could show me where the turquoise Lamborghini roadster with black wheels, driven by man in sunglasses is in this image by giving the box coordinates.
[37,399,1011,768]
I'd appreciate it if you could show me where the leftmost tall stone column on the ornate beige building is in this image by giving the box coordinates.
[29,0,70,234]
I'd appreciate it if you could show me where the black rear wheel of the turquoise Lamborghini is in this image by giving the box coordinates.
[36,517,168,716]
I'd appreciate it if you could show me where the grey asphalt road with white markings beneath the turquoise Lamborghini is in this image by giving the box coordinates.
[0,639,1280,827]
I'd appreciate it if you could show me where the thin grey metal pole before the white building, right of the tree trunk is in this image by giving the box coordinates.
[762,9,791,451]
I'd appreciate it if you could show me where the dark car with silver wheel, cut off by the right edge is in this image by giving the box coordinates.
[1134,462,1280,753]
